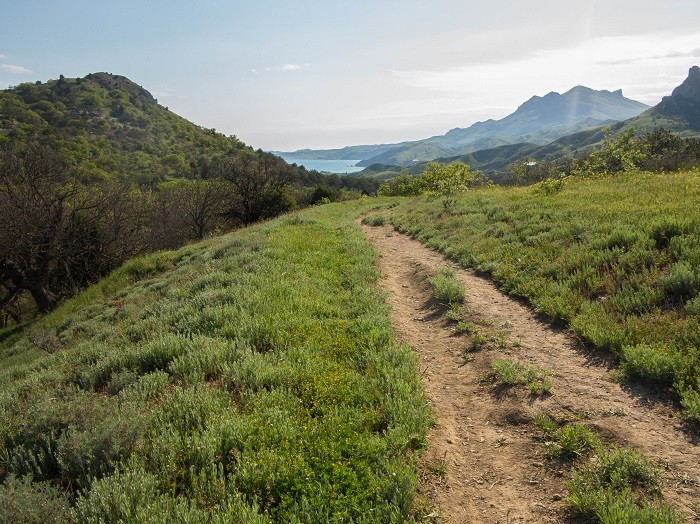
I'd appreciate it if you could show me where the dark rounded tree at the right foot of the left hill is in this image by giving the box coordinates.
[219,151,294,225]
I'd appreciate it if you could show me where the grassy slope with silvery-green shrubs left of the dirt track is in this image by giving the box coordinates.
[0,201,428,523]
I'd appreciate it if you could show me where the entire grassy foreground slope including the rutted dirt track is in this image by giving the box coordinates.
[0,172,700,524]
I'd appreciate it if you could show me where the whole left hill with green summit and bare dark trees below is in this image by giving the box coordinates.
[0,73,376,327]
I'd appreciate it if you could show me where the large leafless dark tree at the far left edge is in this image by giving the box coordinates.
[0,144,139,314]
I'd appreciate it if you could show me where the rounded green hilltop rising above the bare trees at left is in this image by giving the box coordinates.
[0,73,250,184]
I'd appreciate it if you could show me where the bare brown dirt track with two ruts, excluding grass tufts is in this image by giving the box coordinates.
[363,219,700,524]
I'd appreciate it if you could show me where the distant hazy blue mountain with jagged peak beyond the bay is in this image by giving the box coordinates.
[279,86,648,166]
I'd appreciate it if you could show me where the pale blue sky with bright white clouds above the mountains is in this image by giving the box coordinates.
[0,0,700,151]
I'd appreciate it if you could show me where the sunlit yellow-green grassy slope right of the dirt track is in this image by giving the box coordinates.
[393,171,700,420]
